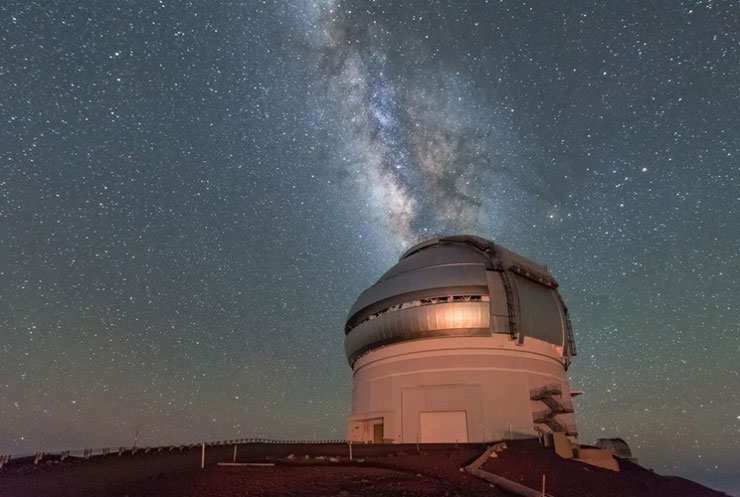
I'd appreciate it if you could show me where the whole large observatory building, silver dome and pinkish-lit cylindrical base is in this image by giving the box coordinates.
[345,236,577,443]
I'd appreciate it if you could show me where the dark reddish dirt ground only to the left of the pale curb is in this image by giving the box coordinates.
[0,446,506,497]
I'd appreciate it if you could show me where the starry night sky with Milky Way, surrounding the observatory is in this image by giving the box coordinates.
[0,0,740,494]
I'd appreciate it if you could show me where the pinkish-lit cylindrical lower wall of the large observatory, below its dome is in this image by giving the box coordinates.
[348,335,575,443]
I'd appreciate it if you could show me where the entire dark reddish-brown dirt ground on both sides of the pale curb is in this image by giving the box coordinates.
[0,440,724,497]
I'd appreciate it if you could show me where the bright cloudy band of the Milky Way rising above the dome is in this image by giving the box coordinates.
[303,3,521,248]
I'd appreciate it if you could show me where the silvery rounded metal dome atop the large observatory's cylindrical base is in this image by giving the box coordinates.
[345,235,575,367]
